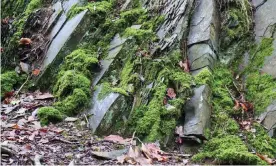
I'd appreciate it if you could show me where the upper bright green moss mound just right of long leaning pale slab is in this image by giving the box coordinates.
[62,49,98,78]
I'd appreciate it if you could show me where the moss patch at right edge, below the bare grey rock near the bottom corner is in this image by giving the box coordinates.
[246,123,276,158]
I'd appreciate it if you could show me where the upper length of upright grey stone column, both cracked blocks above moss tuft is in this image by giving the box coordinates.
[188,0,219,74]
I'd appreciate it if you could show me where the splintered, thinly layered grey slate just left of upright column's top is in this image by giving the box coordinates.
[143,0,194,50]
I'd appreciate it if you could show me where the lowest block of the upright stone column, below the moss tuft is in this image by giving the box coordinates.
[184,85,211,139]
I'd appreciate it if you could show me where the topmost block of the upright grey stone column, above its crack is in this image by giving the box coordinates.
[188,0,219,50]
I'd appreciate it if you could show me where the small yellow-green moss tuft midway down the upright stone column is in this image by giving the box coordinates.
[195,68,213,85]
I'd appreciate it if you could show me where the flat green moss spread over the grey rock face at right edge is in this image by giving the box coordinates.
[245,38,276,115]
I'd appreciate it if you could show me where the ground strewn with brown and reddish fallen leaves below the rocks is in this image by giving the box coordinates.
[1,91,191,165]
